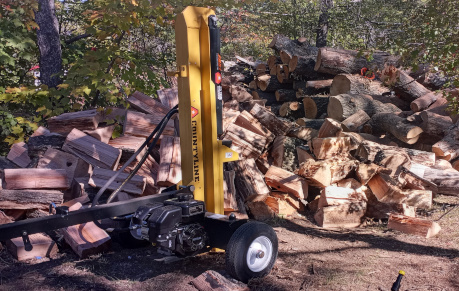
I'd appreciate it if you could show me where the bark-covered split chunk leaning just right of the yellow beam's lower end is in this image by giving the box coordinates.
[227,159,270,200]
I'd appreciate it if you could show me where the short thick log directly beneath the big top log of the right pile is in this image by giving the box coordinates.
[330,74,389,96]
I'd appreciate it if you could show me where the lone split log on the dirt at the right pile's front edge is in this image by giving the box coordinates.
[387,214,441,238]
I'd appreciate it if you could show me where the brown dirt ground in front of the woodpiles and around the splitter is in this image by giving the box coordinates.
[0,196,459,291]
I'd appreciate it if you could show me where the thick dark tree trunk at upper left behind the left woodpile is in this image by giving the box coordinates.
[35,0,62,88]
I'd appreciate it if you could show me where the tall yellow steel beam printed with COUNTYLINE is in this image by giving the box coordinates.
[175,6,239,214]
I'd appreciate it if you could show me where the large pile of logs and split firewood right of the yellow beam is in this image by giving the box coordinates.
[223,35,459,237]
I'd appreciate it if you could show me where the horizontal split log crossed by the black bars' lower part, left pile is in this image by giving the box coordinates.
[88,168,146,195]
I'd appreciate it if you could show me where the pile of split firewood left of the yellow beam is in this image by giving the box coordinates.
[0,89,181,260]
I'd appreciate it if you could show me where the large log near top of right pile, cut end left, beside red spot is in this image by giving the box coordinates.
[314,47,400,75]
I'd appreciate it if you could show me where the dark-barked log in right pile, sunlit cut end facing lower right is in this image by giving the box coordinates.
[370,113,423,144]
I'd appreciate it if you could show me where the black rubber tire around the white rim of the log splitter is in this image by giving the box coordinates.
[225,222,278,283]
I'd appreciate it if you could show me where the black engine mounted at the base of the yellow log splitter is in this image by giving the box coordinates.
[130,195,207,255]
